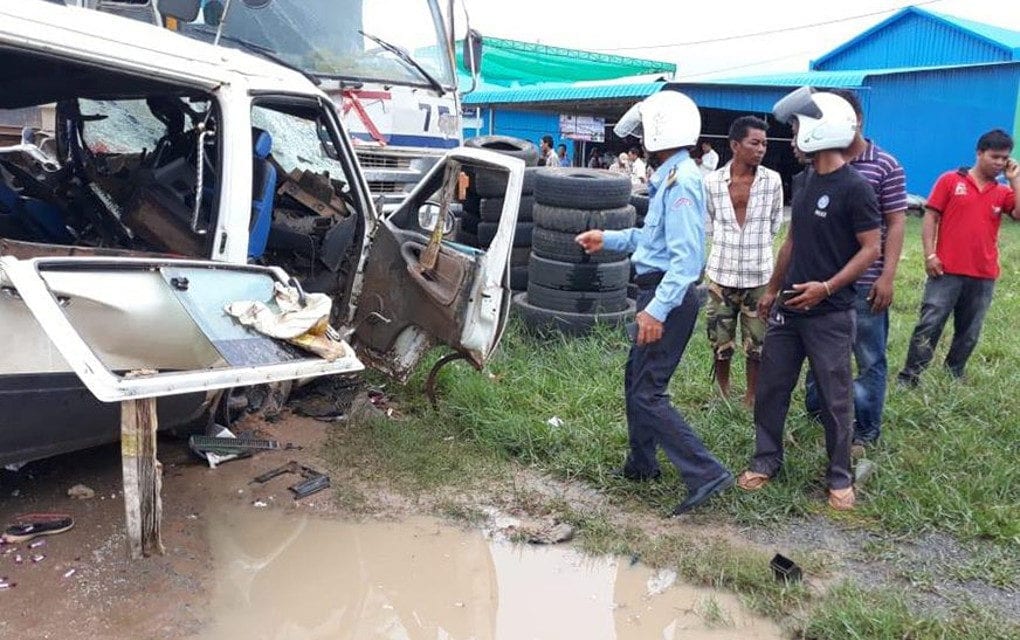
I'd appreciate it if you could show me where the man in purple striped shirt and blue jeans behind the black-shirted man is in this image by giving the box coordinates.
[805,91,907,446]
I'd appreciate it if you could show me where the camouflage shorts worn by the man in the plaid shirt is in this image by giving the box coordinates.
[706,281,765,360]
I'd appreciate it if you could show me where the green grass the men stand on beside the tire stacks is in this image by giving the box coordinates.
[326,219,1020,640]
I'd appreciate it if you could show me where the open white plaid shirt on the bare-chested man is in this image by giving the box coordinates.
[705,163,782,289]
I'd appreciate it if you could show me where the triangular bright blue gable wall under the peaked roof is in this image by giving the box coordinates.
[812,15,1011,70]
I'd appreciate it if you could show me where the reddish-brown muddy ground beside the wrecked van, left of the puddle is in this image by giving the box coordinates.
[0,416,350,640]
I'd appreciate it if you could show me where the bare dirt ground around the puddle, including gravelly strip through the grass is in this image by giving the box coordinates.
[0,396,1020,640]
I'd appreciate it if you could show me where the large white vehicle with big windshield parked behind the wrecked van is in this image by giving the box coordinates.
[69,0,476,209]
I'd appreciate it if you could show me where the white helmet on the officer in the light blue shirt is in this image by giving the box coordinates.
[613,90,701,151]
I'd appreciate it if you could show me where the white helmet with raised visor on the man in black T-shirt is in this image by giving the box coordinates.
[772,87,858,153]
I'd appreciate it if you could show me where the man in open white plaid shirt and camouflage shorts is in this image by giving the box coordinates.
[705,115,782,407]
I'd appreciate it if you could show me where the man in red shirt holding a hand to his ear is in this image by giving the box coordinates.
[899,129,1020,387]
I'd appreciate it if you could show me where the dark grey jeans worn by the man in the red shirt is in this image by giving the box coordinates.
[899,274,996,384]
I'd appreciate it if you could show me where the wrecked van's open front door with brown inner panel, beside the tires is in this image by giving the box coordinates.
[352,147,524,380]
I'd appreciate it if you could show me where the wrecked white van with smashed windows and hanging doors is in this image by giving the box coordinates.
[0,0,523,463]
